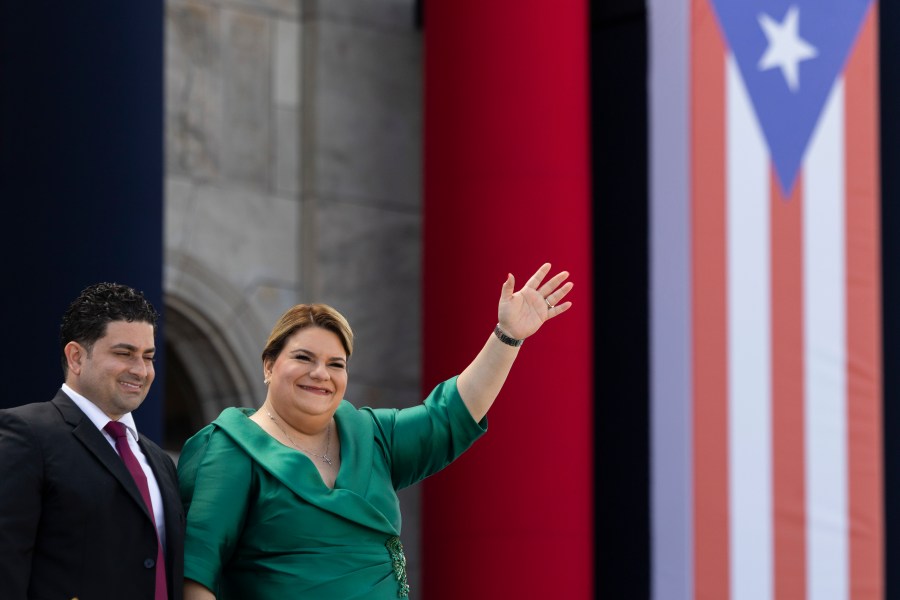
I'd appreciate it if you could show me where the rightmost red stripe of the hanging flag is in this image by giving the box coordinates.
[845,4,884,600]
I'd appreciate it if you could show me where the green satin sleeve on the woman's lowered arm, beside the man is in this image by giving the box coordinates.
[178,424,253,593]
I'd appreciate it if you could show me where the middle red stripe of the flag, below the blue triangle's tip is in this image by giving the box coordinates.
[770,171,806,600]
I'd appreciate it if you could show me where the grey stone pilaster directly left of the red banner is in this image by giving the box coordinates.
[300,0,422,598]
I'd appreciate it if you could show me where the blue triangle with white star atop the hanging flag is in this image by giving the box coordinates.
[710,0,872,194]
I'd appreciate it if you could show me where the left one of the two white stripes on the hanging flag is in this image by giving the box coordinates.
[725,54,773,600]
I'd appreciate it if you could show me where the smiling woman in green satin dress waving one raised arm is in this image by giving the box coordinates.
[178,264,572,600]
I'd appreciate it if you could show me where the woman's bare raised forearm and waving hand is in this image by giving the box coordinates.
[456,263,573,421]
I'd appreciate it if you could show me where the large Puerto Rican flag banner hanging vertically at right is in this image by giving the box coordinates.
[651,0,884,600]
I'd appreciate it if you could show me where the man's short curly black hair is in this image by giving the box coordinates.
[59,283,159,378]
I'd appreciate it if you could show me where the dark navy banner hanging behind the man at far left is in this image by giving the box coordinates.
[0,0,163,440]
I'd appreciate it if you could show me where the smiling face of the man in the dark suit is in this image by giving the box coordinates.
[66,321,156,420]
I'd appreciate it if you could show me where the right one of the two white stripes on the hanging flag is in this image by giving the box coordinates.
[803,78,849,600]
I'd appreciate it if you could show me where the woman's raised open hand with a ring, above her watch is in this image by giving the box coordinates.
[497,263,574,340]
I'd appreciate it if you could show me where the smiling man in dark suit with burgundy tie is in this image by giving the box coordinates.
[0,283,184,600]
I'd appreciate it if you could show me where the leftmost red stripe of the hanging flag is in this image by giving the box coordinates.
[691,0,729,600]
